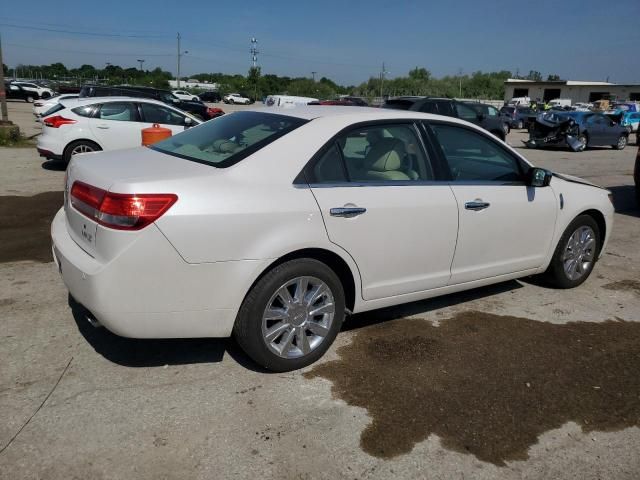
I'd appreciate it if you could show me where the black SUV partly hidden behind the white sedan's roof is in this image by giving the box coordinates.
[382,97,508,141]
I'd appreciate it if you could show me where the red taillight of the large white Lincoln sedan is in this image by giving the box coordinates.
[71,182,178,230]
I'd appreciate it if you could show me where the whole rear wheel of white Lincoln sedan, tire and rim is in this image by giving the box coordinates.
[233,258,345,372]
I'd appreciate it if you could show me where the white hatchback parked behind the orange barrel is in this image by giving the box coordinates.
[37,97,202,163]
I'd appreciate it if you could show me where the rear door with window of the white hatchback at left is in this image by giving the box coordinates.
[88,102,142,150]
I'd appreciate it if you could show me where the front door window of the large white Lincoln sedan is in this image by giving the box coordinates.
[431,124,523,182]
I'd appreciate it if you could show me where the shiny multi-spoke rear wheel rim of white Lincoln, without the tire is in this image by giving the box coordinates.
[262,276,335,359]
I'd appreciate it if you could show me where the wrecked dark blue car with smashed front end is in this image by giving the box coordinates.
[523,111,629,152]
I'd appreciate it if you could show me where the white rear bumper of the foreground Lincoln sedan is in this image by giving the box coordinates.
[51,209,263,338]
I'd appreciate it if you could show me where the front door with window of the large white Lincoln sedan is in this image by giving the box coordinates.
[431,122,557,285]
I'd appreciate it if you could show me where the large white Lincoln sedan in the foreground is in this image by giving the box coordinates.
[51,106,614,371]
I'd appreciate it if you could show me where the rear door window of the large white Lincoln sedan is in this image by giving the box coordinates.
[309,124,434,183]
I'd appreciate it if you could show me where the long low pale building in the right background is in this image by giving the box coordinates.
[504,78,640,103]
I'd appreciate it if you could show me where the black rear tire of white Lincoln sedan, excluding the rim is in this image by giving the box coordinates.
[233,258,345,372]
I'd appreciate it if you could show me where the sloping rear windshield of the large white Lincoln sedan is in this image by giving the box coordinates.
[150,112,307,168]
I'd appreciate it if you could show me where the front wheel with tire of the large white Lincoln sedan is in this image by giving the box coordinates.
[544,215,601,288]
